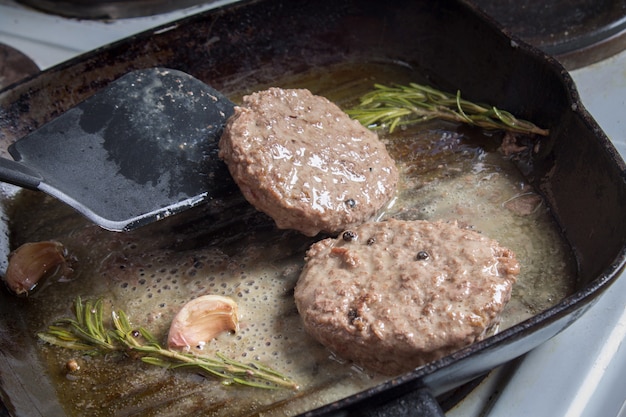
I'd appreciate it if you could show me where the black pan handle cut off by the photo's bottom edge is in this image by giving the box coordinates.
[359,387,445,417]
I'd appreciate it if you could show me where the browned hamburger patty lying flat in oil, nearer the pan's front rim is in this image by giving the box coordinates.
[295,220,519,374]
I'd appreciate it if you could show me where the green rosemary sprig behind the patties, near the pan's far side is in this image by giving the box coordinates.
[346,83,549,136]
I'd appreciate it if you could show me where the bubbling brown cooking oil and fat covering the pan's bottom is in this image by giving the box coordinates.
[4,63,575,417]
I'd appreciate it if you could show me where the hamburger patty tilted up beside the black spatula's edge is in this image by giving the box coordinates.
[219,88,398,236]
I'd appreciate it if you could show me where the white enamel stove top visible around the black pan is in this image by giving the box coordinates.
[0,0,626,417]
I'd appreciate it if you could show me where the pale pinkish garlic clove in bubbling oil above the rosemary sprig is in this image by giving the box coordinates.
[167,295,239,350]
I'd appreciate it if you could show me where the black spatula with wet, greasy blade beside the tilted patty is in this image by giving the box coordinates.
[0,68,234,231]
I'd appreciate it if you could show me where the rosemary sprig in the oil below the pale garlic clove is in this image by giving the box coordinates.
[38,297,298,389]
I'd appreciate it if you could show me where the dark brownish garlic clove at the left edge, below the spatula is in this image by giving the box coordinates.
[4,241,72,295]
